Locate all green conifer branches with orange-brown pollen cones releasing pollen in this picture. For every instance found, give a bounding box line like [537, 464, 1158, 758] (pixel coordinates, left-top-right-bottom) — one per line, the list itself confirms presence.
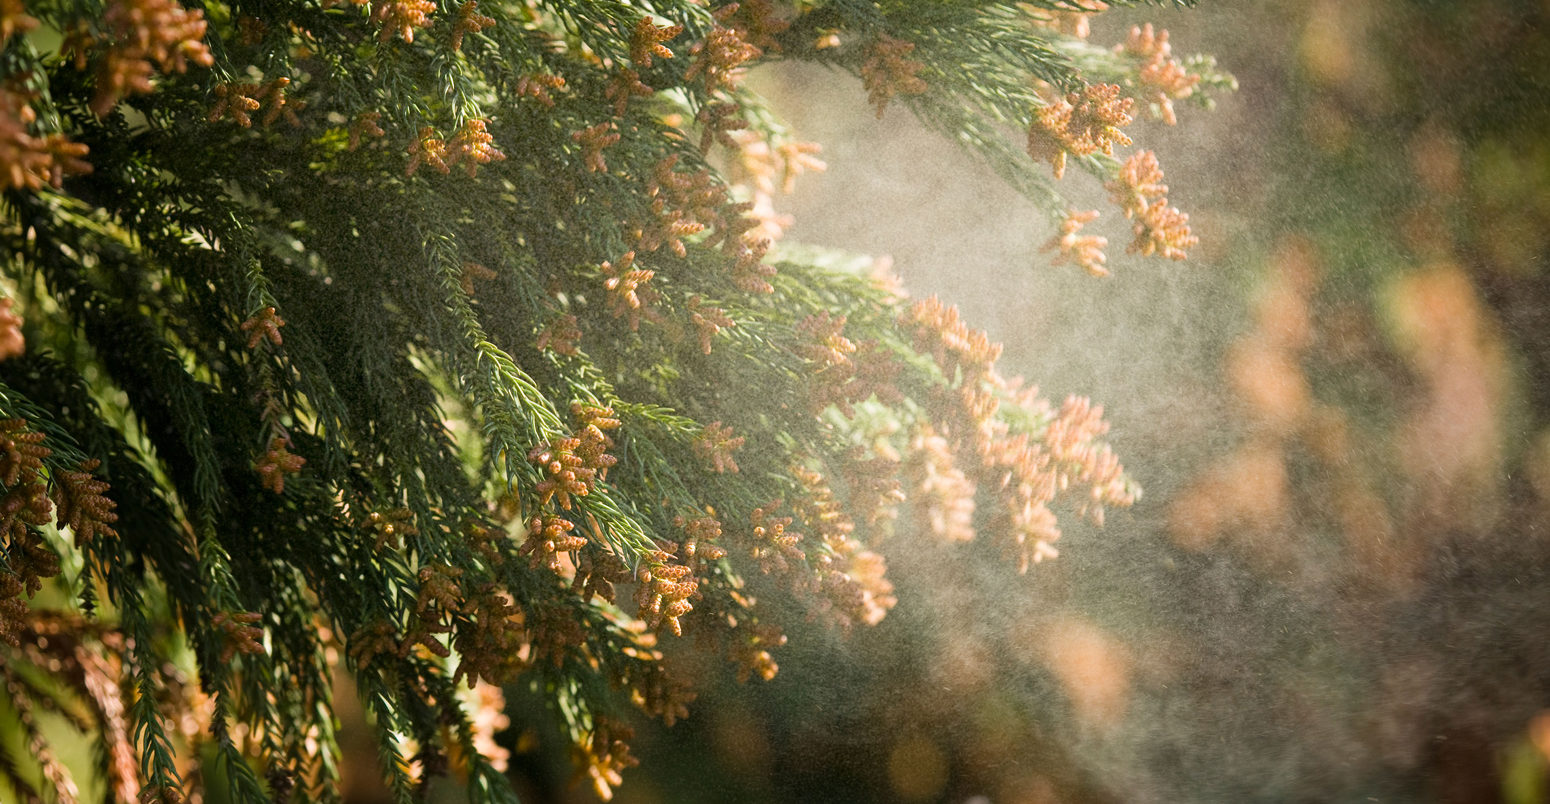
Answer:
[0, 0, 1220, 802]
